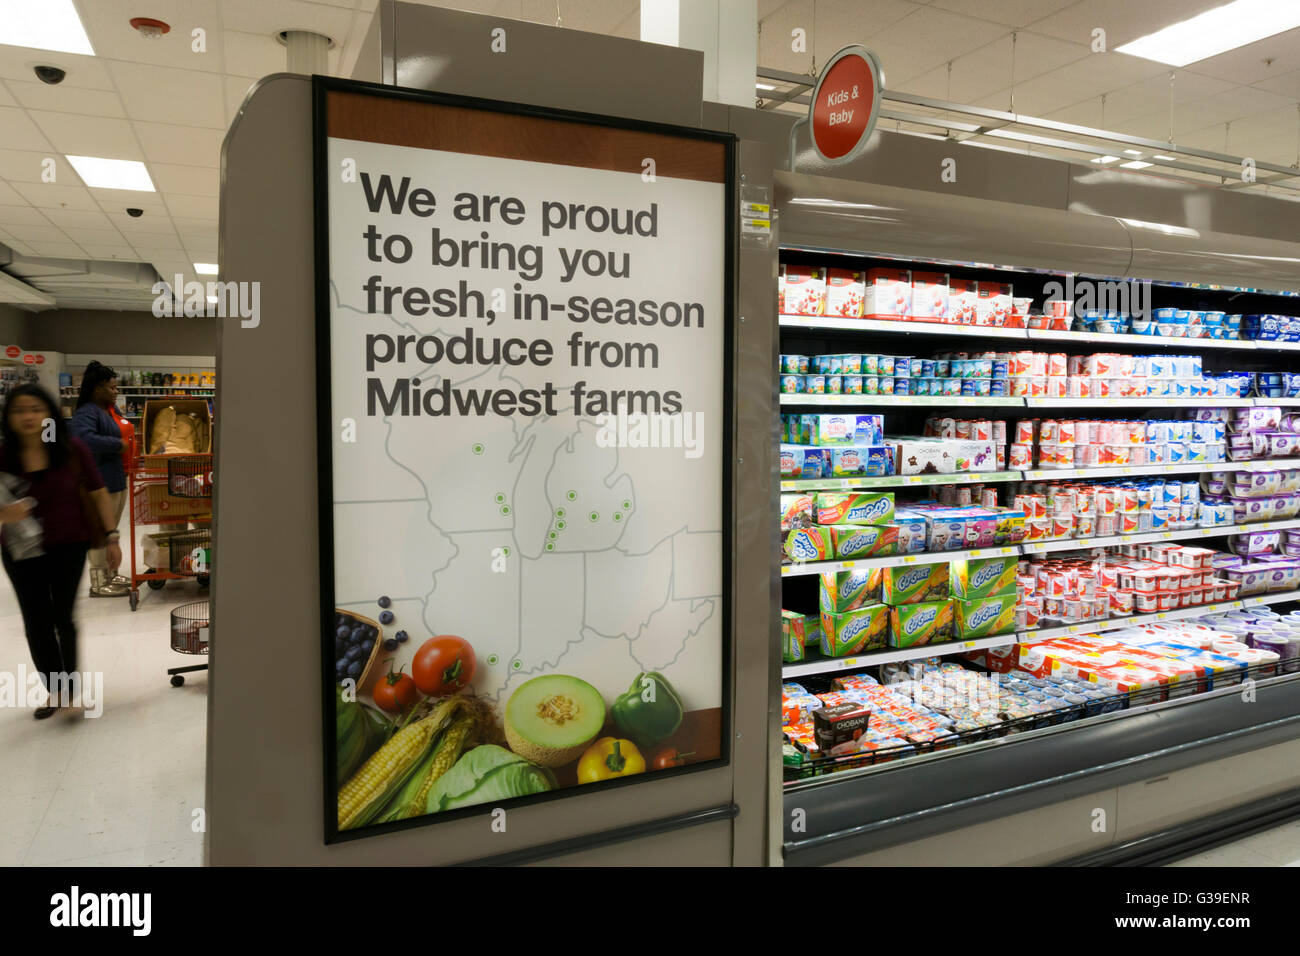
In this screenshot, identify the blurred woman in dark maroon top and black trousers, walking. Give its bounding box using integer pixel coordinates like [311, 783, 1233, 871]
[0, 385, 122, 721]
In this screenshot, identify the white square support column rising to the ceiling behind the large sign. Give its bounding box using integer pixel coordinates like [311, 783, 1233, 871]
[641, 0, 758, 107]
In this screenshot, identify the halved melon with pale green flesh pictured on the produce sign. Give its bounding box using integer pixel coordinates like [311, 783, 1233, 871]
[506, 674, 605, 767]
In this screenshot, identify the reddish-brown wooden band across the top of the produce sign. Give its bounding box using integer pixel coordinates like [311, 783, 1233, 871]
[326, 90, 727, 183]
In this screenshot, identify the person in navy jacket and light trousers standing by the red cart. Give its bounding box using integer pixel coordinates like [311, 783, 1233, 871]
[70, 362, 134, 597]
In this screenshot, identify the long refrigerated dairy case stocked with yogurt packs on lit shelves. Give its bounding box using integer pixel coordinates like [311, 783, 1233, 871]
[769, 173, 1300, 865]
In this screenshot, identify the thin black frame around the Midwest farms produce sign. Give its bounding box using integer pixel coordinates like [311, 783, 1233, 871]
[312, 75, 740, 844]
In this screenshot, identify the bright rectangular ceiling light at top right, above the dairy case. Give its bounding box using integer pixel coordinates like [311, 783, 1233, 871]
[1115, 0, 1300, 66]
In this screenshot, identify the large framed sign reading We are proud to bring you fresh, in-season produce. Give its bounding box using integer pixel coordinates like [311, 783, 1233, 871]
[316, 78, 736, 840]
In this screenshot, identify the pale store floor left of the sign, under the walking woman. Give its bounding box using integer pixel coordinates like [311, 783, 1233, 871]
[0, 575, 207, 866]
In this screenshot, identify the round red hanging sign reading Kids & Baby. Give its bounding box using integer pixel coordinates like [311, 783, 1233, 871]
[809, 44, 884, 163]
